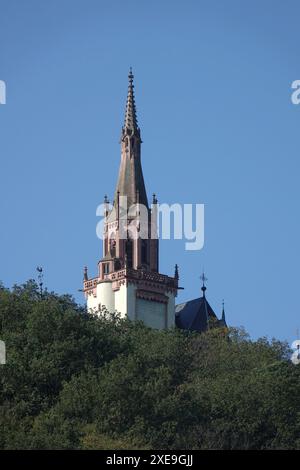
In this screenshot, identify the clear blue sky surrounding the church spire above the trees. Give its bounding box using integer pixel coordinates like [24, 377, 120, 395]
[0, 0, 300, 341]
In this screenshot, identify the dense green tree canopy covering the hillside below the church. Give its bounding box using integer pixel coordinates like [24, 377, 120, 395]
[0, 281, 300, 449]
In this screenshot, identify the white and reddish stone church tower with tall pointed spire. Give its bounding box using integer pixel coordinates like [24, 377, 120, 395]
[83, 69, 178, 329]
